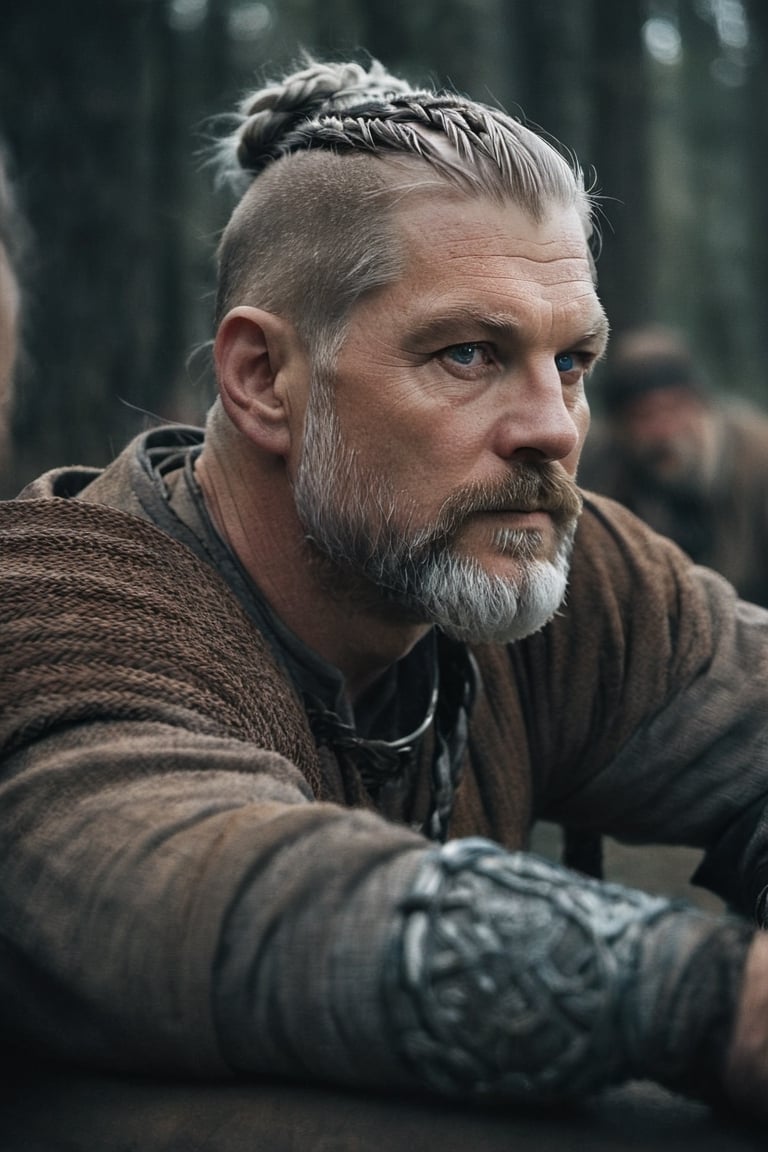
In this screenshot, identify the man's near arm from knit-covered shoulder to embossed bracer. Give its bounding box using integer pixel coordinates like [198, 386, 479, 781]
[0, 497, 759, 1099]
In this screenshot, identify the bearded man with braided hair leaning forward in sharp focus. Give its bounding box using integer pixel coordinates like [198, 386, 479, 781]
[0, 56, 768, 1107]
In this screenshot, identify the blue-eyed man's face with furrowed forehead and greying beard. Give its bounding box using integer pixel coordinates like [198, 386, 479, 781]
[295, 198, 606, 641]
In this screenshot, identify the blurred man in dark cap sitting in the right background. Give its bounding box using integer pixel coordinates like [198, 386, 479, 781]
[579, 325, 768, 605]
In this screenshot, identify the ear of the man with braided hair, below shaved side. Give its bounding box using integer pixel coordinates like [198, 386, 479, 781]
[214, 305, 310, 456]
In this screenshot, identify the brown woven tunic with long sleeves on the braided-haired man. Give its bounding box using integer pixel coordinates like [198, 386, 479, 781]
[0, 433, 768, 1083]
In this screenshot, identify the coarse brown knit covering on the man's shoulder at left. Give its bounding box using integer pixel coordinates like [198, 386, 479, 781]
[0, 498, 313, 765]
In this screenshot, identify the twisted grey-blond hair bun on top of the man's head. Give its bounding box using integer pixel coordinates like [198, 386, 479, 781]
[221, 58, 411, 182]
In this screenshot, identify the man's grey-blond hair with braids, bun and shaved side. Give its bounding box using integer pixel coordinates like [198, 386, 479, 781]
[210, 58, 592, 361]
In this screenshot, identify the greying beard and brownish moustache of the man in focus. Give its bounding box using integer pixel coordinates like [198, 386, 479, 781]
[294, 381, 580, 643]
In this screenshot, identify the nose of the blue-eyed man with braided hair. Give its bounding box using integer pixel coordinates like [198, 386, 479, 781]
[495, 364, 588, 461]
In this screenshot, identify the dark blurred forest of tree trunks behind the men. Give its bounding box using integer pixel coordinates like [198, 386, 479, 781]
[0, 0, 768, 490]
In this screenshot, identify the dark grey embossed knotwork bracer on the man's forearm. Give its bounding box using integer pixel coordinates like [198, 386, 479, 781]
[387, 839, 750, 1100]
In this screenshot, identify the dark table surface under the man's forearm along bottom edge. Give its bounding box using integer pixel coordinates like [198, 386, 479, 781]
[0, 1074, 768, 1152]
